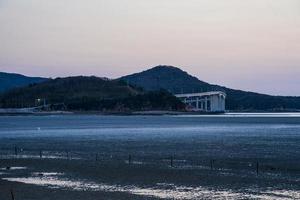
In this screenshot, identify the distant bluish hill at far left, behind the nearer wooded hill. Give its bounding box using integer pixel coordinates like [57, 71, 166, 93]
[0, 72, 48, 93]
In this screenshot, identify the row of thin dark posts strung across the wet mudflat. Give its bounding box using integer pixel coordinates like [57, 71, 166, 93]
[0, 146, 300, 176]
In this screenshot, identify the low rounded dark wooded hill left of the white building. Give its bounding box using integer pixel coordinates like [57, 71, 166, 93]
[0, 76, 184, 112]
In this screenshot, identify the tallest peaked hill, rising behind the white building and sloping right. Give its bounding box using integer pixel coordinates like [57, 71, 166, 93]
[120, 66, 300, 111]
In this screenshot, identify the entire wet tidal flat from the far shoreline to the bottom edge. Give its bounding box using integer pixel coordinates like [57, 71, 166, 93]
[0, 115, 300, 200]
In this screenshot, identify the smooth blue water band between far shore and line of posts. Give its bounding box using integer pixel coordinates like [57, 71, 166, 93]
[0, 114, 300, 160]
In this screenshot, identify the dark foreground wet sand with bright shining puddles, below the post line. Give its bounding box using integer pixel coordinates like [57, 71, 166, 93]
[0, 159, 300, 200]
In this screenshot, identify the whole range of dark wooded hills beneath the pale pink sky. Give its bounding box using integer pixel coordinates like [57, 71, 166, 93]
[0, 66, 300, 111]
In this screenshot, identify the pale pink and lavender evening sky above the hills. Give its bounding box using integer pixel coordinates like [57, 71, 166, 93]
[0, 0, 300, 96]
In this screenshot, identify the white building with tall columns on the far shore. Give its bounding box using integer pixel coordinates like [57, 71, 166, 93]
[175, 91, 226, 112]
